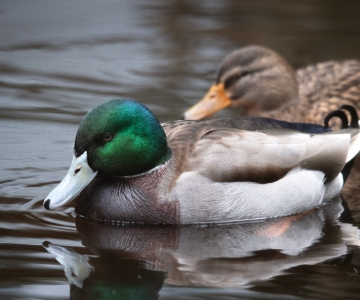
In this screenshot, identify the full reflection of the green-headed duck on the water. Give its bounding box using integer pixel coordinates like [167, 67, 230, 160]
[44, 198, 360, 299]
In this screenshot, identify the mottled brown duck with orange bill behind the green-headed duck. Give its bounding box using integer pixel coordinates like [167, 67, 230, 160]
[184, 46, 360, 124]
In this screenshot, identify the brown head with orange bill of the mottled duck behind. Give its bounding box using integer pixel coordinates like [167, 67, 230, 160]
[183, 46, 299, 120]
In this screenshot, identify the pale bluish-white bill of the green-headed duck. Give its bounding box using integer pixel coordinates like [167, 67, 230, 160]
[44, 152, 97, 209]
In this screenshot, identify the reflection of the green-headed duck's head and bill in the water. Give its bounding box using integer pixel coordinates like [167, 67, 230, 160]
[44, 243, 166, 300]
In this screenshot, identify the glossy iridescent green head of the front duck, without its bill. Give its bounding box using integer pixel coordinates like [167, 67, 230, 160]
[75, 99, 171, 176]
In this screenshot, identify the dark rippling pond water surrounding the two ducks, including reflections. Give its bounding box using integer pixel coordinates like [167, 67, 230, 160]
[0, 0, 360, 299]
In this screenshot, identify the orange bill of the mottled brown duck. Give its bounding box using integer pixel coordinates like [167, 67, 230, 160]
[184, 82, 231, 120]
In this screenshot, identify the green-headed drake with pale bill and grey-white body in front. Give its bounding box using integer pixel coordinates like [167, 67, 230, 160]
[43, 98, 360, 224]
